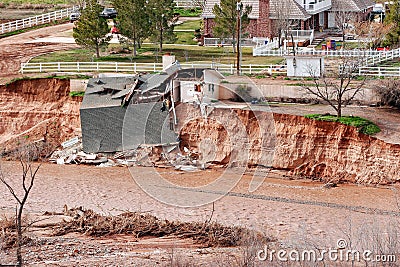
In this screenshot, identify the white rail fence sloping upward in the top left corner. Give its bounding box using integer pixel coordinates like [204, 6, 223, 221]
[0, 7, 78, 34]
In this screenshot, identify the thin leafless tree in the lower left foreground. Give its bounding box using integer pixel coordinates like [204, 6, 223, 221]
[0, 145, 42, 266]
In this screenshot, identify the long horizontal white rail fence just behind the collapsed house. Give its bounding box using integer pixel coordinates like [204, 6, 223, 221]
[20, 62, 286, 74]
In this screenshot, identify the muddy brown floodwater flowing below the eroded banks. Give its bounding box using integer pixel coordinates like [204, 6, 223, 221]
[0, 162, 399, 247]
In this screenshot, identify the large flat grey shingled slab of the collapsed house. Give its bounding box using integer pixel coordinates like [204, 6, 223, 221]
[81, 102, 177, 153]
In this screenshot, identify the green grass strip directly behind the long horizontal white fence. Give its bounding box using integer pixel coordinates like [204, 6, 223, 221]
[31, 44, 283, 65]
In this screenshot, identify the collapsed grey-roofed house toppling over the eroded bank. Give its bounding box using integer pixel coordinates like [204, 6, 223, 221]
[80, 62, 224, 153]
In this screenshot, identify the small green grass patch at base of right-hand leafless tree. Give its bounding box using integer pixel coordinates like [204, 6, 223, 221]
[304, 114, 381, 135]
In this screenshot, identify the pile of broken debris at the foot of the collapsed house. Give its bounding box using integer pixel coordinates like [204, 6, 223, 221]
[49, 137, 208, 171]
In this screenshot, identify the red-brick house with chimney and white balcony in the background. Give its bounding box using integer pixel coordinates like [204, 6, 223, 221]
[202, 0, 374, 38]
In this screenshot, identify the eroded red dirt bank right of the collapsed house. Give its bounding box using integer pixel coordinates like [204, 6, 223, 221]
[180, 106, 400, 184]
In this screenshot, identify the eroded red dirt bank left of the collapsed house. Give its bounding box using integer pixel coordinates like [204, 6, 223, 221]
[0, 78, 80, 153]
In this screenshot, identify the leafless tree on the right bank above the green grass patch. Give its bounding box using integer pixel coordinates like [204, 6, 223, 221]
[302, 57, 365, 118]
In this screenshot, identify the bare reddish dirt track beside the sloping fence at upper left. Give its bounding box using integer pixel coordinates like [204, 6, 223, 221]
[0, 23, 78, 84]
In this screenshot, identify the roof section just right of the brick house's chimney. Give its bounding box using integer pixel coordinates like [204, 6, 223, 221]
[269, 0, 311, 20]
